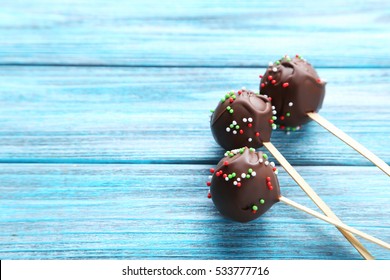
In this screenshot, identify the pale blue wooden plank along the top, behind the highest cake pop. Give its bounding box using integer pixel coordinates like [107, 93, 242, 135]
[0, 0, 390, 67]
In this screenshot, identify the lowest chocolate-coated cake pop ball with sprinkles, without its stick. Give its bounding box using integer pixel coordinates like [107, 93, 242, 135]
[210, 147, 280, 222]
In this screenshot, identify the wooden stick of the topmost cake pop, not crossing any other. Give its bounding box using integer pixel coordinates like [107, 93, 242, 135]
[307, 113, 390, 176]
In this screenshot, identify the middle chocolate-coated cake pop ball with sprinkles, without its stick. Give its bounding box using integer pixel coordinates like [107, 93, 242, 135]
[210, 90, 276, 150]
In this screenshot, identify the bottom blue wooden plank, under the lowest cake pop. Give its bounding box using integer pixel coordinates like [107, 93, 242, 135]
[0, 164, 390, 259]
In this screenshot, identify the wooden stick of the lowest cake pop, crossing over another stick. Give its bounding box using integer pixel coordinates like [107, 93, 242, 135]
[279, 196, 390, 250]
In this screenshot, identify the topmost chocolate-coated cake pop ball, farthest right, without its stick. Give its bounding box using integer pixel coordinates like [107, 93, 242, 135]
[260, 56, 326, 129]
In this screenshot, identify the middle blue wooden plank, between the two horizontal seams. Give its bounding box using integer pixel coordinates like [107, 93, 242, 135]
[0, 67, 390, 165]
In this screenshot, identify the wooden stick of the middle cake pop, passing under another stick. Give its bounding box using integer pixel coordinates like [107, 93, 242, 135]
[263, 142, 374, 260]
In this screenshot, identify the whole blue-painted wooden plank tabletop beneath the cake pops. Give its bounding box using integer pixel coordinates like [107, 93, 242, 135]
[0, 0, 390, 259]
